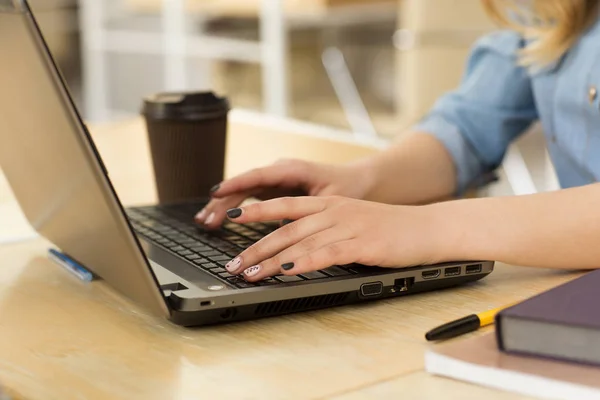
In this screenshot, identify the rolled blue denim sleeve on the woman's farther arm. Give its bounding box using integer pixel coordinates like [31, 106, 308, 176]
[413, 31, 538, 194]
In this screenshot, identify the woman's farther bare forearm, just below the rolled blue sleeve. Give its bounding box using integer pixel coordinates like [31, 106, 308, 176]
[359, 133, 456, 204]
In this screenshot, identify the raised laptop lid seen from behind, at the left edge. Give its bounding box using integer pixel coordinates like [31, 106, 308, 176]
[0, 0, 169, 316]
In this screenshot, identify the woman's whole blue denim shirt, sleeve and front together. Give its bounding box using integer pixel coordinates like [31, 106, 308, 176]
[414, 21, 600, 193]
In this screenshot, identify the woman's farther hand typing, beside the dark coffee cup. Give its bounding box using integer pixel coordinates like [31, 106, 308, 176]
[196, 160, 375, 229]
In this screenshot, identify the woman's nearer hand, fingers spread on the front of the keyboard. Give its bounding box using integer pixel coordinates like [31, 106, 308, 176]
[226, 197, 444, 282]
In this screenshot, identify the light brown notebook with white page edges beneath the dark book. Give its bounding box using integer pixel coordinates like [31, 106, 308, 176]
[425, 333, 600, 400]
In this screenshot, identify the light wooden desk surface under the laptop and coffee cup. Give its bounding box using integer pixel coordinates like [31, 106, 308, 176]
[0, 115, 576, 400]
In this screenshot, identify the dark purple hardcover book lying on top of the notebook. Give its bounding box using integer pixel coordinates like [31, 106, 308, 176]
[496, 270, 600, 365]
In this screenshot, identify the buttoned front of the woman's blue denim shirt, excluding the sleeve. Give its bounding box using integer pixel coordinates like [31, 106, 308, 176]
[531, 18, 600, 188]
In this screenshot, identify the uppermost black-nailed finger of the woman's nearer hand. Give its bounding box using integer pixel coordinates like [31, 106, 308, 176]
[227, 197, 328, 224]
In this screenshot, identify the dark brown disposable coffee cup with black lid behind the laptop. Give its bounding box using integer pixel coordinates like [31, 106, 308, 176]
[142, 92, 229, 204]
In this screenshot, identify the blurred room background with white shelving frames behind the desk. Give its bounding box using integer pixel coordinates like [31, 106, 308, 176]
[2, 0, 557, 209]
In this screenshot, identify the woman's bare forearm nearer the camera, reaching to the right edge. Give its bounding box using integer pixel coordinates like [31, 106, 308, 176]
[434, 184, 600, 269]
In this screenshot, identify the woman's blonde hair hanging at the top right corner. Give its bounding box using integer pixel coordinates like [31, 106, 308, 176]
[482, 0, 600, 66]
